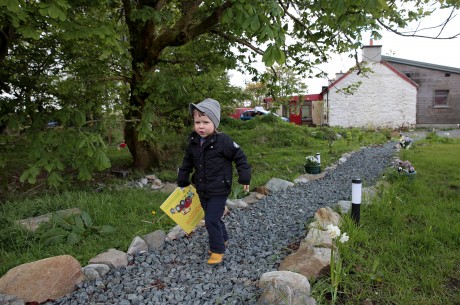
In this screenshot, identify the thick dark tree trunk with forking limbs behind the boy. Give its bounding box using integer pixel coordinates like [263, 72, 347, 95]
[122, 0, 229, 171]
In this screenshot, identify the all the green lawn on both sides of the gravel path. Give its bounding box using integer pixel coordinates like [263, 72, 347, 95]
[0, 121, 460, 304]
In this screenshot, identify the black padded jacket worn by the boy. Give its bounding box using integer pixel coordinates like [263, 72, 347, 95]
[177, 132, 251, 198]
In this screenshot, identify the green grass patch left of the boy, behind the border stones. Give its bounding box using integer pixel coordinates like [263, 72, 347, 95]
[0, 188, 173, 273]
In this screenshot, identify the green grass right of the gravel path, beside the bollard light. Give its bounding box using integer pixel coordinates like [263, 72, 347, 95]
[313, 139, 460, 305]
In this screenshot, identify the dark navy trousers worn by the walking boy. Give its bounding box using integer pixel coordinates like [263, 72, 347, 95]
[200, 197, 228, 253]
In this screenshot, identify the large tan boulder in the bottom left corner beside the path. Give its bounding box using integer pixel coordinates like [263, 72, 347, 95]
[0, 255, 85, 303]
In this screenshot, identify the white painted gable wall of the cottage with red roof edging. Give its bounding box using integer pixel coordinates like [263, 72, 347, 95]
[328, 62, 417, 128]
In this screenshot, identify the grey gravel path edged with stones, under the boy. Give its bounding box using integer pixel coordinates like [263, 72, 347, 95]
[46, 143, 395, 305]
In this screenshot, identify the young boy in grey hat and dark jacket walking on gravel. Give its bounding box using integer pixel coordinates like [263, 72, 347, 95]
[177, 98, 251, 264]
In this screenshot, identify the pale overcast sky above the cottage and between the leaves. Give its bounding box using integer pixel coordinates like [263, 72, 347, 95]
[229, 8, 460, 94]
